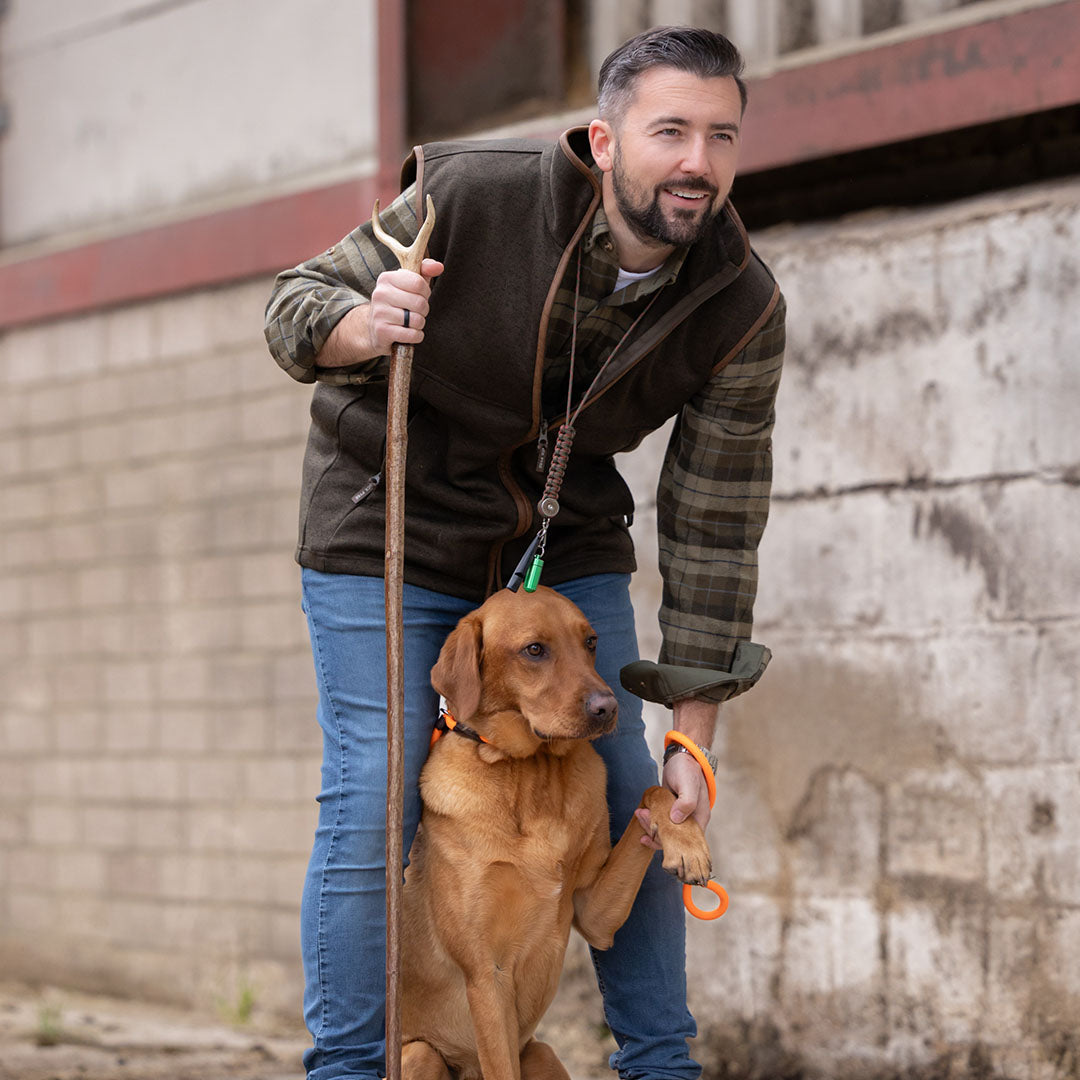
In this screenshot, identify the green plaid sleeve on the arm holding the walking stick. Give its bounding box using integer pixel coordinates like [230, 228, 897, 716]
[265, 187, 419, 386]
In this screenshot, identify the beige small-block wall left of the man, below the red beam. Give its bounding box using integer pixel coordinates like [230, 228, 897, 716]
[0, 281, 318, 1014]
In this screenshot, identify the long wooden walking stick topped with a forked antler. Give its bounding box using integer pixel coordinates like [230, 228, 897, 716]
[372, 195, 435, 1080]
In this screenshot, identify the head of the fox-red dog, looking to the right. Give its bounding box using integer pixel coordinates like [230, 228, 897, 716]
[431, 586, 618, 757]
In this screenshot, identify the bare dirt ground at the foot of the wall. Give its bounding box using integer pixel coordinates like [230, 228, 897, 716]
[0, 966, 615, 1080]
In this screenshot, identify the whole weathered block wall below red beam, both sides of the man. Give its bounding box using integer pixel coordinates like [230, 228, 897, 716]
[0, 172, 1080, 1078]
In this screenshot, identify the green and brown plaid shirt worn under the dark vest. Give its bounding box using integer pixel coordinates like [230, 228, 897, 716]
[266, 187, 784, 700]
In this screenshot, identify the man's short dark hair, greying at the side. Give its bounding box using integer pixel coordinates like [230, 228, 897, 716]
[596, 26, 746, 123]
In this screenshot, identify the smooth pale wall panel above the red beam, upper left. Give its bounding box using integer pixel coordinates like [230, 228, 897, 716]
[0, 0, 376, 245]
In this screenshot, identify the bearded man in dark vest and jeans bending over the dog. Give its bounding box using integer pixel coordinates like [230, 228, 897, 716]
[267, 28, 784, 1080]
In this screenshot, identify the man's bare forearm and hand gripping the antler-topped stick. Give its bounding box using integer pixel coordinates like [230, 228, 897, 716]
[315, 259, 445, 367]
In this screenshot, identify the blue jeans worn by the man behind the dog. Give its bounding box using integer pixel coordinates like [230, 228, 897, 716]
[301, 569, 701, 1080]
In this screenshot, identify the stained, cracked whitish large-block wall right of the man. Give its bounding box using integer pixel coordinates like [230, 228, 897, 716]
[622, 181, 1080, 1077]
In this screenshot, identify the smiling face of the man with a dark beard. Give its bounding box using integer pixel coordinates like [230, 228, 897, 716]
[611, 67, 742, 247]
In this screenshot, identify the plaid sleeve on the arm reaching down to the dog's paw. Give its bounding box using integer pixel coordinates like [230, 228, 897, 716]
[657, 297, 785, 701]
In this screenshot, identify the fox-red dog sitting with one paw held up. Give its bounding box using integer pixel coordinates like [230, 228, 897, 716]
[402, 586, 712, 1080]
